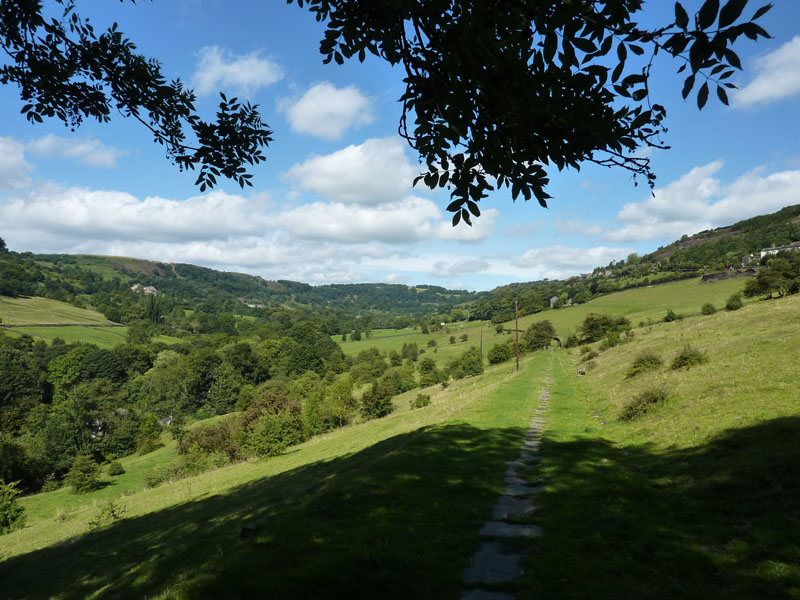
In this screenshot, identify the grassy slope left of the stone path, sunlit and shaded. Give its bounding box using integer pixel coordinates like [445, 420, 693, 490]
[0, 353, 548, 598]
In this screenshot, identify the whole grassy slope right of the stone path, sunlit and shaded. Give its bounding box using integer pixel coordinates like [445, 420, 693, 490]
[521, 297, 800, 600]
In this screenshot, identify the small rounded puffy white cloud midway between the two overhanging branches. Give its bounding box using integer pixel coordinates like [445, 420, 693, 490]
[280, 82, 375, 140]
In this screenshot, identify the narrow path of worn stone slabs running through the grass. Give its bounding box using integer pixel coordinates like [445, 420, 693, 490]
[460, 372, 552, 600]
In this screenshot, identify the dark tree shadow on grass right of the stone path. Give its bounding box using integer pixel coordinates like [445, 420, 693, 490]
[521, 417, 800, 600]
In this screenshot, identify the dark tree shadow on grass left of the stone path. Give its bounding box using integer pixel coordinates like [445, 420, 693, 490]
[0, 424, 523, 599]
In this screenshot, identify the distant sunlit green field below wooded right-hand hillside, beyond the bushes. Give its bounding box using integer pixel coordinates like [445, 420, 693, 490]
[506, 278, 745, 337]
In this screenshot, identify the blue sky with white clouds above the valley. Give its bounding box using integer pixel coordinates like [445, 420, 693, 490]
[0, 0, 800, 290]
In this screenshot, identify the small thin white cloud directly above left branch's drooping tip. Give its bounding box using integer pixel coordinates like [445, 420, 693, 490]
[192, 46, 283, 95]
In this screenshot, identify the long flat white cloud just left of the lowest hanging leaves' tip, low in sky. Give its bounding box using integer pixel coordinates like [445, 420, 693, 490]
[277, 196, 441, 244]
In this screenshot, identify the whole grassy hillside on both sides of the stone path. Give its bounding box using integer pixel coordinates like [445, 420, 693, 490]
[0, 282, 800, 600]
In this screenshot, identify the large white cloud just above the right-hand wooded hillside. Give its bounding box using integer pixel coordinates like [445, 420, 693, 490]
[606, 161, 800, 242]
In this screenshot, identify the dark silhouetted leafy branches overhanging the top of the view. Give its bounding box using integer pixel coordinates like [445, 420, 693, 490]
[0, 0, 771, 225]
